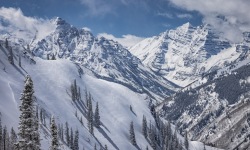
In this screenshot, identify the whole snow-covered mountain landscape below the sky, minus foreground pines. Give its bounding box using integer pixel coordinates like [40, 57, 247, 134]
[0, 17, 250, 150]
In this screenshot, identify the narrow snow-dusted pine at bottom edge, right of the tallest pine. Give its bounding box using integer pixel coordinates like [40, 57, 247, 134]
[50, 116, 59, 150]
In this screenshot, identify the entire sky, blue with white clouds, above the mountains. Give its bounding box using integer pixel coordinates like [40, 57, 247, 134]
[0, 0, 250, 47]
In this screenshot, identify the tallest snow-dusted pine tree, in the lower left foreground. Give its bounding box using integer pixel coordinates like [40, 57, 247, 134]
[16, 75, 39, 150]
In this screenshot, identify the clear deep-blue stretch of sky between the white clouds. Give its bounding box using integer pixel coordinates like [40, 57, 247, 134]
[1, 0, 202, 37]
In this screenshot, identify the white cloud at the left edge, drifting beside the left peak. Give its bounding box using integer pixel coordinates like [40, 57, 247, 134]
[0, 7, 55, 42]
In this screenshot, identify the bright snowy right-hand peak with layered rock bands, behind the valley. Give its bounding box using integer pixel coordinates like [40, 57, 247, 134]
[130, 23, 247, 87]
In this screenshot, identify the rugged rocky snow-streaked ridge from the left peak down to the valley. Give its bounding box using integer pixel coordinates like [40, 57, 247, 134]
[31, 18, 178, 100]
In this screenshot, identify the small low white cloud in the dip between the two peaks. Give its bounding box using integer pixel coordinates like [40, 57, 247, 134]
[97, 33, 145, 48]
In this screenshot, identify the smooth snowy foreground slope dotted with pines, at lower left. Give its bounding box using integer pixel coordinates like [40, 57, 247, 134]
[0, 37, 223, 150]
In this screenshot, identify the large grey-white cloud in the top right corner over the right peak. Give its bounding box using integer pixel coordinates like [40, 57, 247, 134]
[170, 0, 250, 42]
